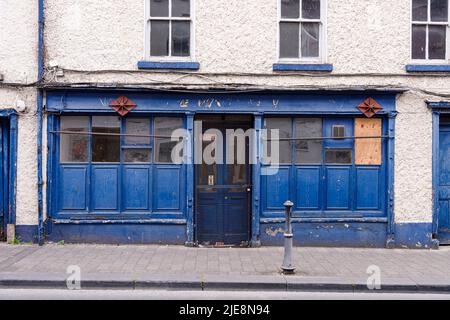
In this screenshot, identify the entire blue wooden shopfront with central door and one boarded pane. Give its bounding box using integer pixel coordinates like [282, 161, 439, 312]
[45, 89, 397, 247]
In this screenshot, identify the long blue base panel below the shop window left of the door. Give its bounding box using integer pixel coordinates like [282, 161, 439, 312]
[46, 224, 187, 245]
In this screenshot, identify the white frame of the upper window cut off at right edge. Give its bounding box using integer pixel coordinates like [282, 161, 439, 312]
[409, 0, 450, 65]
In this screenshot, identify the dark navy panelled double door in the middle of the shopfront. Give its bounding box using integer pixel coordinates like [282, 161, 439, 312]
[196, 119, 251, 245]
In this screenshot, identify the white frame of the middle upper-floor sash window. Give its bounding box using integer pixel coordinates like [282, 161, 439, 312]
[277, 0, 328, 63]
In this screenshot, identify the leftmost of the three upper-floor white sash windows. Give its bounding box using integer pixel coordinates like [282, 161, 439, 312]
[146, 0, 193, 59]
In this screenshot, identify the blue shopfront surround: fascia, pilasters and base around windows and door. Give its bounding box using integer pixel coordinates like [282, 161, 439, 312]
[46, 90, 397, 247]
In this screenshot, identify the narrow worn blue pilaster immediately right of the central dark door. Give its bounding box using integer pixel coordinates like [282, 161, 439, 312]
[251, 114, 263, 247]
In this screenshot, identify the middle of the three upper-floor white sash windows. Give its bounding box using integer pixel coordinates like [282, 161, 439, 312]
[279, 0, 326, 61]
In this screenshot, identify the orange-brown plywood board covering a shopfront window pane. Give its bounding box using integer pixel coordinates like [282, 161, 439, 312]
[355, 118, 382, 165]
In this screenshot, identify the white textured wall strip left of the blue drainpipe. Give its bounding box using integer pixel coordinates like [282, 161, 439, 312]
[0, 0, 38, 225]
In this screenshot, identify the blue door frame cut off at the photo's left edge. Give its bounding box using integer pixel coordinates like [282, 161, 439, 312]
[0, 109, 17, 240]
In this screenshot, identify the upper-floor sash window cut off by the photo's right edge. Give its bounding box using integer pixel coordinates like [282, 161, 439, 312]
[411, 0, 450, 62]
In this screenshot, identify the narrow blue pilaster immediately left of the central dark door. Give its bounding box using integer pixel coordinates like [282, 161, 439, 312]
[185, 114, 195, 246]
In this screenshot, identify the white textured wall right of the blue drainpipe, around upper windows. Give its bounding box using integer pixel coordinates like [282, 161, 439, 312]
[22, 0, 450, 222]
